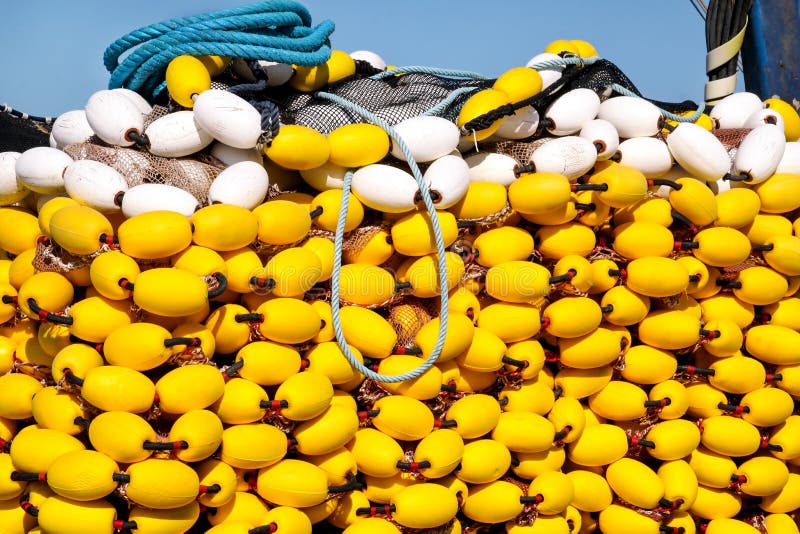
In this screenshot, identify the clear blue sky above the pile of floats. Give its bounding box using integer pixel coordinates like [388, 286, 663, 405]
[0, 0, 724, 116]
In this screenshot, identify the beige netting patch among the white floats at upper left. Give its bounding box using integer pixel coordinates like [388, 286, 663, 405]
[64, 142, 225, 206]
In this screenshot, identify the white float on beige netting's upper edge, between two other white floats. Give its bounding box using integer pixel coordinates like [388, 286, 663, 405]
[144, 110, 214, 158]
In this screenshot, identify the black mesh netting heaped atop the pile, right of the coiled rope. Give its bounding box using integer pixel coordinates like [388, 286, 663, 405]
[268, 59, 697, 134]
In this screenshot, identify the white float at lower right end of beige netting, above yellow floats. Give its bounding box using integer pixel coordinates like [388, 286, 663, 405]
[208, 161, 269, 210]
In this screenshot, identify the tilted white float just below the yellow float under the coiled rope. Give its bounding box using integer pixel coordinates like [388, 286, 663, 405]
[194, 89, 261, 148]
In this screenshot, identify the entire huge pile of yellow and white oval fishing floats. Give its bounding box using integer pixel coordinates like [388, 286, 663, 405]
[0, 37, 800, 534]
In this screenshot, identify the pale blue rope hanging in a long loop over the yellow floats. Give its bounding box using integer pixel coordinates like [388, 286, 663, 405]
[315, 92, 449, 382]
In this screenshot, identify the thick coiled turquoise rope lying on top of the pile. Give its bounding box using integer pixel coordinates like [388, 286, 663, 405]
[103, 0, 334, 96]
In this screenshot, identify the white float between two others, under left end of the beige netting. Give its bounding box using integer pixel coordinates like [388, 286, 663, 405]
[64, 159, 128, 211]
